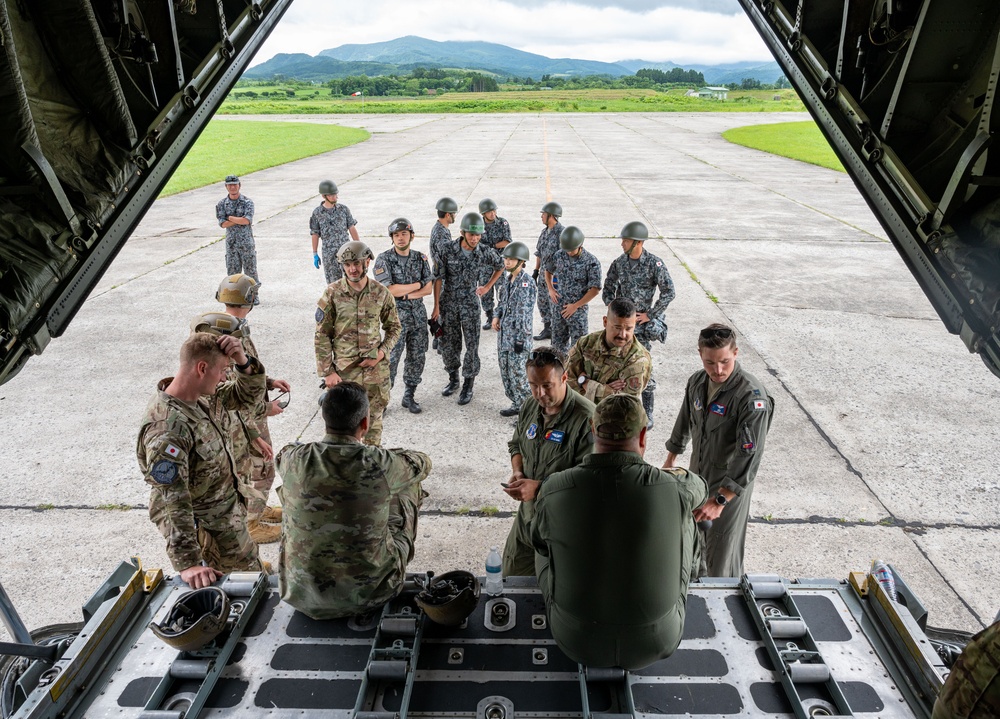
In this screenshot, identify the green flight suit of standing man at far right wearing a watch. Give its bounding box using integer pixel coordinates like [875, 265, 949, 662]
[667, 362, 774, 577]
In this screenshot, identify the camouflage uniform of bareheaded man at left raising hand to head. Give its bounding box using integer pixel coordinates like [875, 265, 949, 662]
[136, 357, 265, 573]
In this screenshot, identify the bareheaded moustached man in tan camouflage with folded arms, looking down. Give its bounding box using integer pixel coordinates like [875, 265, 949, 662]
[566, 297, 653, 404]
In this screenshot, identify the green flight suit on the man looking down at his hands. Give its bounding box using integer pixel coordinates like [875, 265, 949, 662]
[503, 387, 594, 577]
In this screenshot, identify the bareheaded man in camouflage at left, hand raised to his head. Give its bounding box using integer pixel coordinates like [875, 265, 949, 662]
[136, 332, 265, 589]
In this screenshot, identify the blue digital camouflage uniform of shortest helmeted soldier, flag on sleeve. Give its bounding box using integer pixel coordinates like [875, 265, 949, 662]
[494, 268, 535, 407]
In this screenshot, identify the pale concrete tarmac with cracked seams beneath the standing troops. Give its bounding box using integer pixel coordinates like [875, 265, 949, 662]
[0, 113, 1000, 640]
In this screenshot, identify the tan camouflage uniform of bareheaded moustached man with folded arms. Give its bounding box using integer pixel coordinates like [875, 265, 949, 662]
[566, 330, 653, 404]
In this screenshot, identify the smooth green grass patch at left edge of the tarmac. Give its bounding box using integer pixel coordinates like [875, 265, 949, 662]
[161, 120, 371, 197]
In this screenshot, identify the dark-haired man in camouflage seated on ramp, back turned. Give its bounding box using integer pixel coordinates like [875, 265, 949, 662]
[278, 382, 431, 619]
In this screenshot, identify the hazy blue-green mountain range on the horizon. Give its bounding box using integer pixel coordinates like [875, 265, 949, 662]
[243, 35, 782, 85]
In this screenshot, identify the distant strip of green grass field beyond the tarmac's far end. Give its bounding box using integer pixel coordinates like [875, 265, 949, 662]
[219, 85, 805, 115]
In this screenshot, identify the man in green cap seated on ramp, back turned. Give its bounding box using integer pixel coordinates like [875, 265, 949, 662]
[531, 394, 708, 670]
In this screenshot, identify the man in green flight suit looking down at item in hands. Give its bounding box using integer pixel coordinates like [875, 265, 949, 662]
[503, 347, 594, 577]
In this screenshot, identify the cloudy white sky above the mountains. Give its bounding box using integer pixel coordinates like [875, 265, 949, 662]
[254, 0, 772, 65]
